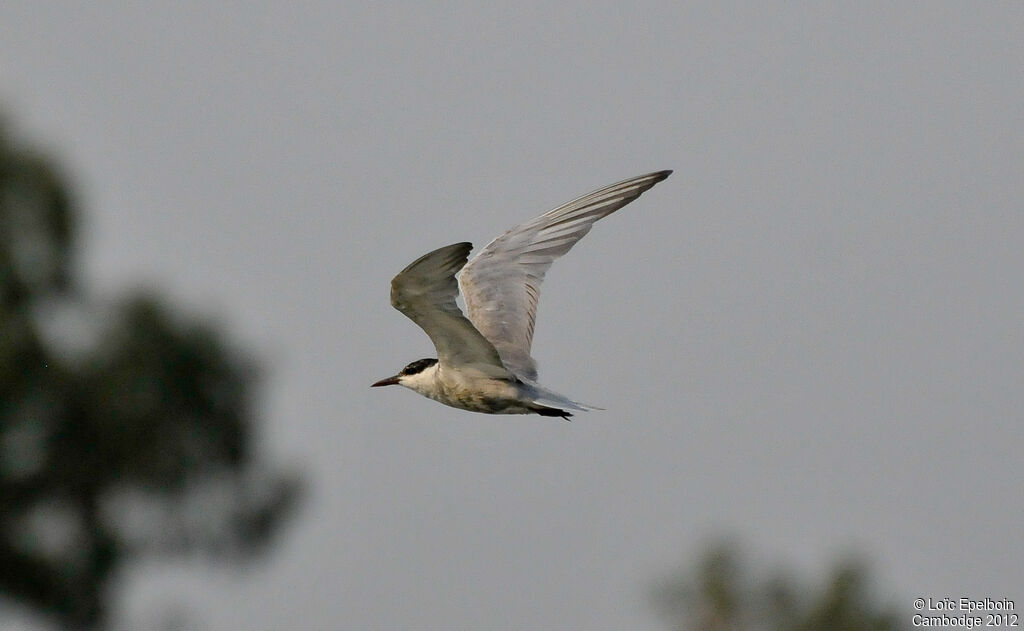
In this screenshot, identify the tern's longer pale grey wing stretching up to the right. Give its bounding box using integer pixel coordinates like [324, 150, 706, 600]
[459, 171, 672, 380]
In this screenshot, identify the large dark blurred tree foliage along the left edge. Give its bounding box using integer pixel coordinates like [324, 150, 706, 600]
[0, 117, 299, 630]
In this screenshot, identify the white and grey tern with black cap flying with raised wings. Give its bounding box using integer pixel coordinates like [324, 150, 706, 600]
[371, 170, 672, 420]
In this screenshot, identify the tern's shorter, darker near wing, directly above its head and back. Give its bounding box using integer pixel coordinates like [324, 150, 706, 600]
[391, 243, 508, 377]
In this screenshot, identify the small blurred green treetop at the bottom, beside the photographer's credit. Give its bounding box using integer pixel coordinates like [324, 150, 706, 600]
[654, 543, 905, 631]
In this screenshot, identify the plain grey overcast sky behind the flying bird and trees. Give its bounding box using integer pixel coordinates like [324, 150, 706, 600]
[0, 2, 1024, 631]
